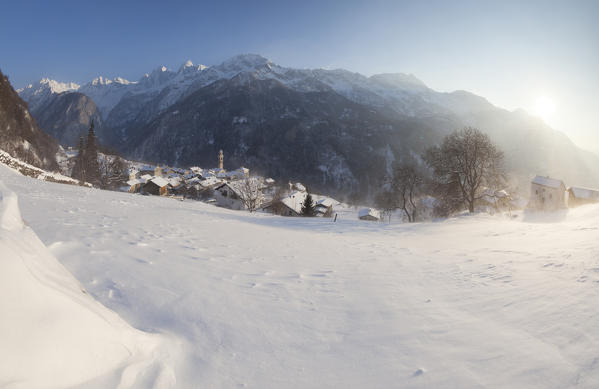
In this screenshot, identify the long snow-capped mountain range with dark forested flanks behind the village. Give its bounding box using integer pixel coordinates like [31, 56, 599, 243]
[19, 54, 599, 195]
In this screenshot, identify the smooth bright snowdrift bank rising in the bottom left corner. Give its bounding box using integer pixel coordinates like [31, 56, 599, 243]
[0, 177, 174, 388]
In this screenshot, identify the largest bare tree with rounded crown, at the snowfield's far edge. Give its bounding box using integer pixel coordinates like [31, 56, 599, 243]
[424, 127, 504, 212]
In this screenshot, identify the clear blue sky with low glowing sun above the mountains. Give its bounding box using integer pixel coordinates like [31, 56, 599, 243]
[0, 0, 599, 152]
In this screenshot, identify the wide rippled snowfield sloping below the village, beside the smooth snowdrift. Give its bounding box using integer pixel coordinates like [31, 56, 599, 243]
[0, 162, 599, 388]
